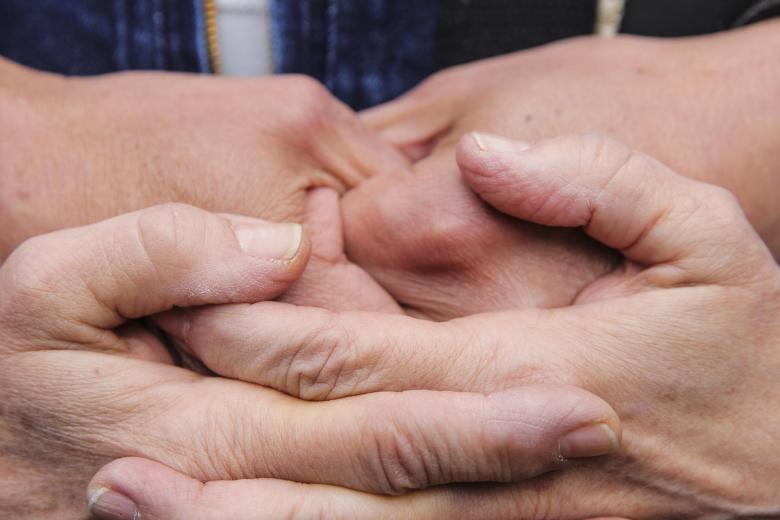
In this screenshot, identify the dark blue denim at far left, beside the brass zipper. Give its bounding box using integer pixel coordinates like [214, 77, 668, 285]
[0, 0, 208, 75]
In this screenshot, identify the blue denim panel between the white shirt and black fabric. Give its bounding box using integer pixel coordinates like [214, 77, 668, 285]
[271, 0, 439, 109]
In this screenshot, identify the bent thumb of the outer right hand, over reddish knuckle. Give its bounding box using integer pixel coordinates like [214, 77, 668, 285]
[457, 130, 767, 285]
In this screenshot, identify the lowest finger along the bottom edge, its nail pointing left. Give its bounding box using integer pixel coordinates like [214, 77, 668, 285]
[87, 458, 672, 520]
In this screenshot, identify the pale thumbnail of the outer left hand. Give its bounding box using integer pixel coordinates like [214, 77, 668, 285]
[233, 222, 303, 260]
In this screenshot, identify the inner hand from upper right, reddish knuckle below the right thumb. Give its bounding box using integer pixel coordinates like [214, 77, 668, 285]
[344, 20, 780, 319]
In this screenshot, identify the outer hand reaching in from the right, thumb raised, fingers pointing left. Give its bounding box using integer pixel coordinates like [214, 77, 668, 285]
[120, 136, 780, 519]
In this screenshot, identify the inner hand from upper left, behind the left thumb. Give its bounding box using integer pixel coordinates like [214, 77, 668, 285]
[0, 60, 406, 310]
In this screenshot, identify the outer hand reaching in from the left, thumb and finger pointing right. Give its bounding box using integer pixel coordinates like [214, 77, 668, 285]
[0, 198, 620, 519]
